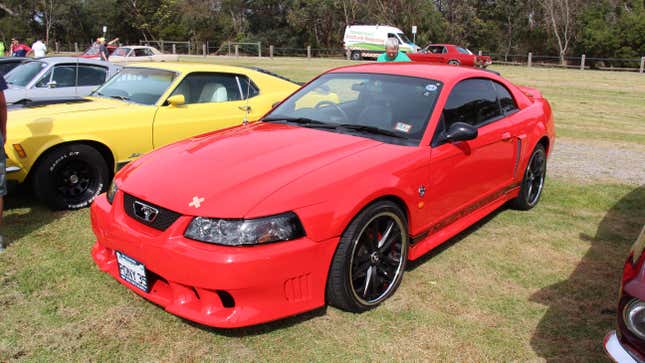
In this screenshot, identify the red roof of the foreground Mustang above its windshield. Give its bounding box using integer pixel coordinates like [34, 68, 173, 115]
[329, 62, 495, 83]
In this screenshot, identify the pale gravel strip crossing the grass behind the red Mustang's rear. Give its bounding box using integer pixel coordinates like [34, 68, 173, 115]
[547, 139, 645, 185]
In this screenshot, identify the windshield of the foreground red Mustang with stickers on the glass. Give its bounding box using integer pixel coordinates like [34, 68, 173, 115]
[264, 73, 442, 145]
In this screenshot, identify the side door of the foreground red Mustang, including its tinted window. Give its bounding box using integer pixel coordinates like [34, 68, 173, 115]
[428, 78, 517, 226]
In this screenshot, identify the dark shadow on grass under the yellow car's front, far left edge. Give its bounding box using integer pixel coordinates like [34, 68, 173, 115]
[0, 186, 65, 248]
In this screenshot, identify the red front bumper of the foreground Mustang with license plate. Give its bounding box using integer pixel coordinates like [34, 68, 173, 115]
[91, 192, 338, 328]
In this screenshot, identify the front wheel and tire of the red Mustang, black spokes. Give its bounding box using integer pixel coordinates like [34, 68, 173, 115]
[327, 201, 408, 313]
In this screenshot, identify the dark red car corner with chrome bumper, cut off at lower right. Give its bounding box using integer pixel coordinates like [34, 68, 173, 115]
[604, 226, 645, 362]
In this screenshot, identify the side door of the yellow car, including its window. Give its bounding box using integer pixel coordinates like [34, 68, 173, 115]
[153, 72, 261, 148]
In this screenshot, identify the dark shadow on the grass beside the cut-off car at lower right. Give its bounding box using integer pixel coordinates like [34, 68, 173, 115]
[530, 185, 645, 361]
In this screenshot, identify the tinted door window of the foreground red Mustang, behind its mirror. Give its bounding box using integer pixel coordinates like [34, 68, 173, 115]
[443, 78, 501, 129]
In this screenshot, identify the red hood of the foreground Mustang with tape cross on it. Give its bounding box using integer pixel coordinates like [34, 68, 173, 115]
[117, 122, 382, 218]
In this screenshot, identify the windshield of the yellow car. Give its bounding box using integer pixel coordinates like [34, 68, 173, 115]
[93, 68, 175, 105]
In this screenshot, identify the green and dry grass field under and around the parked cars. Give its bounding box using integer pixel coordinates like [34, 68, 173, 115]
[0, 58, 645, 362]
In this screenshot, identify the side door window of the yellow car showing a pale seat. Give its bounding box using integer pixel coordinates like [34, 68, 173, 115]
[171, 73, 242, 104]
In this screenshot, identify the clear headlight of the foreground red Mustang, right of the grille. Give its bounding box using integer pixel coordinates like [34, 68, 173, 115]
[184, 212, 305, 246]
